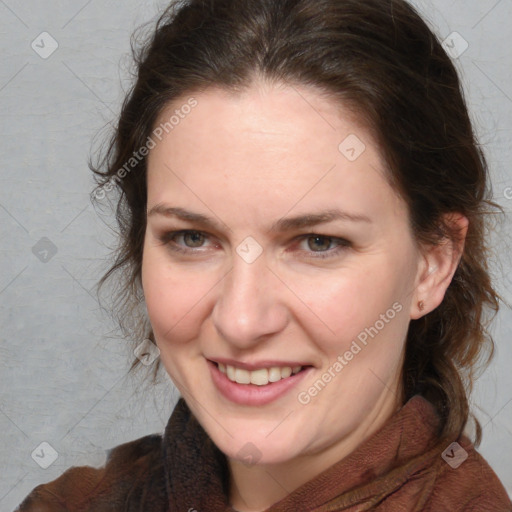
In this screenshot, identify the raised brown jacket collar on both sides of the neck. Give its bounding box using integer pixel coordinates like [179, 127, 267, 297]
[163, 395, 440, 512]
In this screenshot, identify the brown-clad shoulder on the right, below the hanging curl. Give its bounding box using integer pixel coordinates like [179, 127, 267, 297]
[427, 437, 512, 512]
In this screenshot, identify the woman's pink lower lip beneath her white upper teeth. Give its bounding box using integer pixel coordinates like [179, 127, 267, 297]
[208, 361, 312, 405]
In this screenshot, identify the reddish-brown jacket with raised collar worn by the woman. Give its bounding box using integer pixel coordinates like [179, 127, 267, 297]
[18, 395, 512, 512]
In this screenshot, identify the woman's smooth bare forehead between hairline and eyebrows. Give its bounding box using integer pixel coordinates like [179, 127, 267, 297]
[148, 83, 403, 230]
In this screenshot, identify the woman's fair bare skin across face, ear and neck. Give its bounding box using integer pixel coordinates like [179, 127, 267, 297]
[142, 81, 467, 512]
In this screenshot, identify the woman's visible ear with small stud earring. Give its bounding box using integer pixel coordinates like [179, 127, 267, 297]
[410, 213, 469, 320]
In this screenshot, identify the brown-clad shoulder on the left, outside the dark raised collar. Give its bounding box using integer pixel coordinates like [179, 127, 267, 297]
[16, 434, 164, 512]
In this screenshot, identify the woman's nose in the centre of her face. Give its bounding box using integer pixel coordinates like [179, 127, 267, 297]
[212, 254, 289, 350]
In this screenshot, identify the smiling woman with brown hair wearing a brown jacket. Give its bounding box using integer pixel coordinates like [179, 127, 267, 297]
[19, 0, 512, 512]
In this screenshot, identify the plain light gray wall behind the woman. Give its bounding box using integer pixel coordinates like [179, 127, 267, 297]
[0, 0, 512, 511]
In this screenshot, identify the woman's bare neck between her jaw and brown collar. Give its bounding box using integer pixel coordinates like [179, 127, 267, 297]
[228, 393, 400, 512]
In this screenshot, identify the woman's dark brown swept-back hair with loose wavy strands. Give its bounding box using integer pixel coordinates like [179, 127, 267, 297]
[91, 0, 499, 444]
